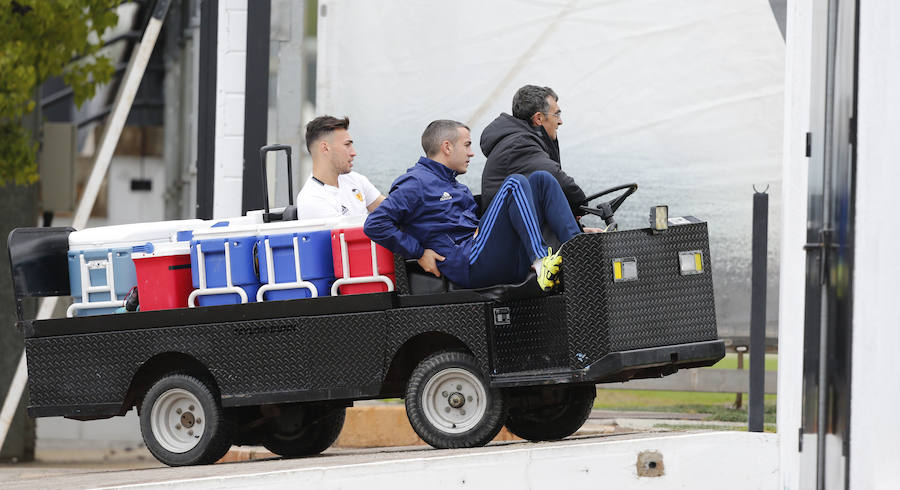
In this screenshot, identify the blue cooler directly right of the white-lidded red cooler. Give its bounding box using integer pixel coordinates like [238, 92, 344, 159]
[188, 222, 260, 306]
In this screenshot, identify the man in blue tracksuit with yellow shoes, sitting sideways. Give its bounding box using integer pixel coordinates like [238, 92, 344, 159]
[365, 120, 580, 290]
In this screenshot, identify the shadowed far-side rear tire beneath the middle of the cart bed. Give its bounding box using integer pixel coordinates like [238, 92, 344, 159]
[263, 405, 346, 458]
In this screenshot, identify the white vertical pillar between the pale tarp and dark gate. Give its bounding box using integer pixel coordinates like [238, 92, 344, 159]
[777, 0, 814, 488]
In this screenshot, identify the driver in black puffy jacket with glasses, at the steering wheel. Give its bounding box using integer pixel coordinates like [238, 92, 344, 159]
[481, 85, 585, 216]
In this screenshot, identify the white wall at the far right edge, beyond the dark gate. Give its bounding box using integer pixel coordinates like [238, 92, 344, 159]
[852, 0, 900, 488]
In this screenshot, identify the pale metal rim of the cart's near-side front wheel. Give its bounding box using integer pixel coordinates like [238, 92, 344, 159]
[422, 368, 487, 434]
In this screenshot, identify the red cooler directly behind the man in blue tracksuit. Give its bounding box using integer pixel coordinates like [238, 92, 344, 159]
[331, 226, 394, 296]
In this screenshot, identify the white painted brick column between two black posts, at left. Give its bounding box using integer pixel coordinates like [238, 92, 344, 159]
[213, 0, 248, 218]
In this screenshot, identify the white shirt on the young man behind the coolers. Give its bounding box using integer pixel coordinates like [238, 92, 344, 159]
[297, 172, 381, 219]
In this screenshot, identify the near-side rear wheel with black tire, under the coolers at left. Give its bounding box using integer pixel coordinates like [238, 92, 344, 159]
[141, 374, 234, 466]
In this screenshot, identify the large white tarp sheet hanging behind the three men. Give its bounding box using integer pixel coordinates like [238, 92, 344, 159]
[316, 0, 784, 336]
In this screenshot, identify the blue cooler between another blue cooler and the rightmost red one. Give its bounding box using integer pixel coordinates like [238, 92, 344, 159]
[256, 228, 334, 301]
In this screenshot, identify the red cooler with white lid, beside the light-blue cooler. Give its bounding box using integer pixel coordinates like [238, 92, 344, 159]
[131, 242, 194, 311]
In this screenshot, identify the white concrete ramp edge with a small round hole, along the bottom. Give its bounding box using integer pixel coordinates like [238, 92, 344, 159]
[84, 432, 779, 490]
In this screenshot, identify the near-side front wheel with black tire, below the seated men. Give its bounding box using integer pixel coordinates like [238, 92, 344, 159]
[406, 351, 505, 449]
